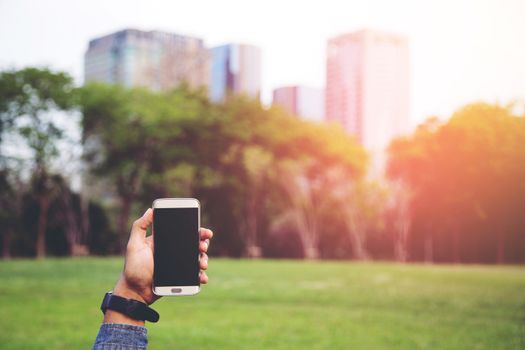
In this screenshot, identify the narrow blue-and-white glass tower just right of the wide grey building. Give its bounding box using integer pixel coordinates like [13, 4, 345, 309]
[209, 44, 261, 102]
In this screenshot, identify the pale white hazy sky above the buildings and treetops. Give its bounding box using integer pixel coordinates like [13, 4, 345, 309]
[0, 0, 525, 125]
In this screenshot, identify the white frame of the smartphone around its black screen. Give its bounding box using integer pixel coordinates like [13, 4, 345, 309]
[152, 198, 201, 296]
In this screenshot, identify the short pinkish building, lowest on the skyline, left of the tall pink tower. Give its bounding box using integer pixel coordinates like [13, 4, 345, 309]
[273, 86, 324, 122]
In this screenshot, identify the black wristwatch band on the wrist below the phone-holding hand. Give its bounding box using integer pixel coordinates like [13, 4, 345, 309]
[100, 292, 159, 322]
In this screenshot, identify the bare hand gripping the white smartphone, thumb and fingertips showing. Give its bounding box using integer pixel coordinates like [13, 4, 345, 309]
[109, 208, 213, 314]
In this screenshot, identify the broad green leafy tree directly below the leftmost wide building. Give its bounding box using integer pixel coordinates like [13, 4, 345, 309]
[80, 83, 212, 244]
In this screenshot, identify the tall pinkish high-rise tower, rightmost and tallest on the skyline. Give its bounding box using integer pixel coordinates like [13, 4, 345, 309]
[326, 30, 410, 154]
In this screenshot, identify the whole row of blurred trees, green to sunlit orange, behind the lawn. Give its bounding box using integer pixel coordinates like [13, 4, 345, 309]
[0, 68, 525, 262]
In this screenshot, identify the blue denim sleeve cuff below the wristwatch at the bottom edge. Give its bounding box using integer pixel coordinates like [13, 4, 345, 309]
[92, 323, 148, 350]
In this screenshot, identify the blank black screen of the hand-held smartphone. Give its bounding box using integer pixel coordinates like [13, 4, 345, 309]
[153, 208, 200, 287]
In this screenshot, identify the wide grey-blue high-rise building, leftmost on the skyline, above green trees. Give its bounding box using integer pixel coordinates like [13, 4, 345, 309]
[84, 29, 209, 90]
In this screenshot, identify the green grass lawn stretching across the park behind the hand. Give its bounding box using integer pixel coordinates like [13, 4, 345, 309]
[0, 258, 525, 349]
